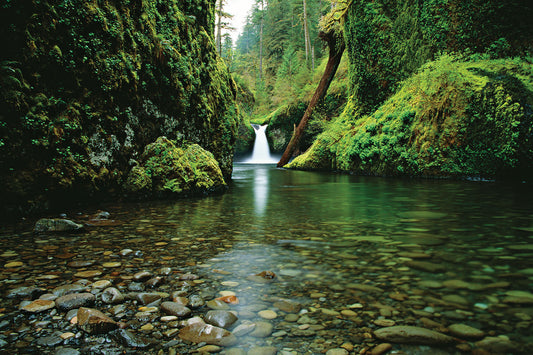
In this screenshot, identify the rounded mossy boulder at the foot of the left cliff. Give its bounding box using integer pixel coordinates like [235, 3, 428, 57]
[124, 137, 226, 196]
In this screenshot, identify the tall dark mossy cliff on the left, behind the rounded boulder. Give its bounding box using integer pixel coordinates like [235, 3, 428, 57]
[0, 0, 238, 212]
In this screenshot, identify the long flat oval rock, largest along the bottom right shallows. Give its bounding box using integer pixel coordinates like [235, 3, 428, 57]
[374, 325, 454, 345]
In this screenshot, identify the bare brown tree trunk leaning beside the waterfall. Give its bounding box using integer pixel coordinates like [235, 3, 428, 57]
[278, 31, 345, 168]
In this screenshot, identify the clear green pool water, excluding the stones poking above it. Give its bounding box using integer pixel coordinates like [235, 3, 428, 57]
[0, 164, 533, 354]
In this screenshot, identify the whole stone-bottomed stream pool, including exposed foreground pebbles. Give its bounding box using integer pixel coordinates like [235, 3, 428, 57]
[0, 164, 533, 355]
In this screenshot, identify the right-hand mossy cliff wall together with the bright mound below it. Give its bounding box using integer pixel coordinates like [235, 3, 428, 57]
[289, 0, 533, 178]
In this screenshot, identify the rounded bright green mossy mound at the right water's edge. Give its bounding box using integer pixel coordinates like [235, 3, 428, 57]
[289, 56, 533, 178]
